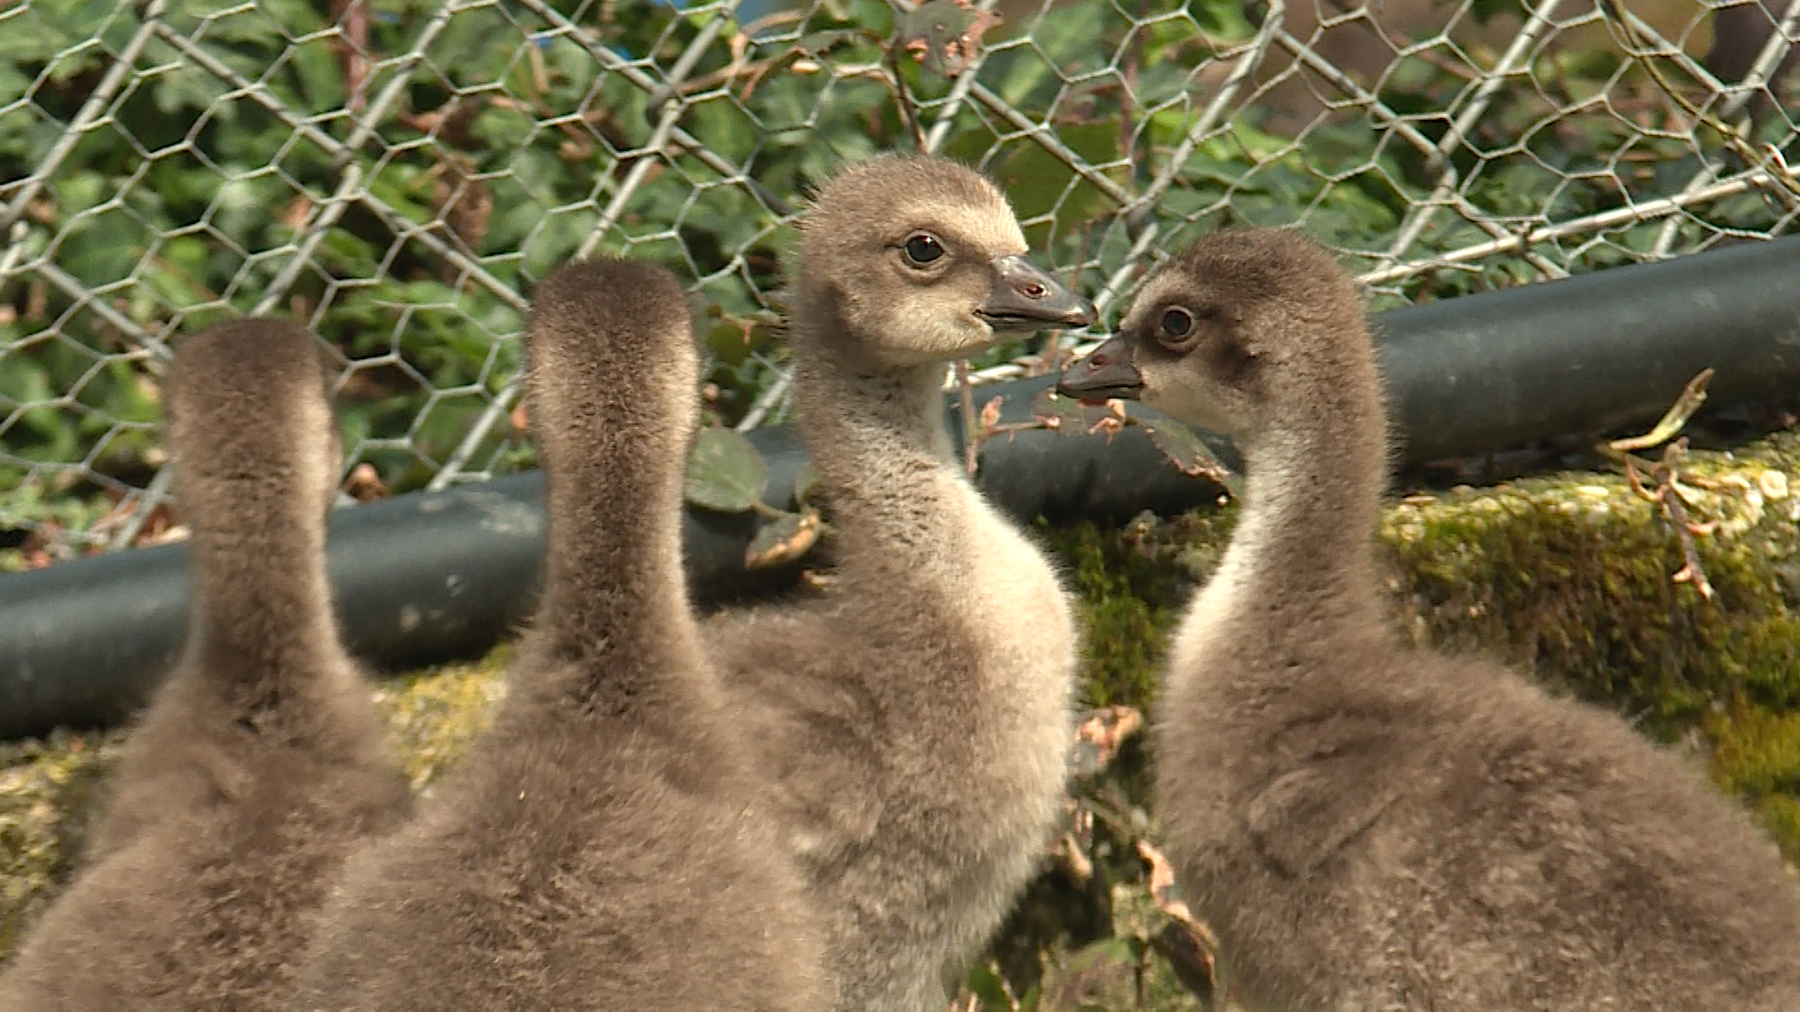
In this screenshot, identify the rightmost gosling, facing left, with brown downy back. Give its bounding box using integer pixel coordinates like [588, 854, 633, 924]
[1062, 230, 1800, 1012]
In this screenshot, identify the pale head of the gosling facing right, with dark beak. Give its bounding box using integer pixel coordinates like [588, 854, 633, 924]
[799, 155, 1094, 366]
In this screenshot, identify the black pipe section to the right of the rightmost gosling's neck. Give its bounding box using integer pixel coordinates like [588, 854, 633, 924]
[1377, 236, 1800, 461]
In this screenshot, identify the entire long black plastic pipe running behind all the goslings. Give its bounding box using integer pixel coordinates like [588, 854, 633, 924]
[0, 236, 1800, 738]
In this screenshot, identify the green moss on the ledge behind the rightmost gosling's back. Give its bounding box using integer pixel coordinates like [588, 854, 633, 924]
[1382, 475, 1800, 727]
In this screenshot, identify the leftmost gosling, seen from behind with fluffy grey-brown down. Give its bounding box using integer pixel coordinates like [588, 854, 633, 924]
[0, 321, 409, 1012]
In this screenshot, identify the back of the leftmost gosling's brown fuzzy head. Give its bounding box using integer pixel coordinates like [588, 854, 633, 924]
[164, 319, 344, 520]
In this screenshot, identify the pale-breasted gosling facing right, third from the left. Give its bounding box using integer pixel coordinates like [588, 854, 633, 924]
[707, 155, 1093, 1012]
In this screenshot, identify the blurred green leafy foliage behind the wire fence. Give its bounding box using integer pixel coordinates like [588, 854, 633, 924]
[0, 0, 1777, 518]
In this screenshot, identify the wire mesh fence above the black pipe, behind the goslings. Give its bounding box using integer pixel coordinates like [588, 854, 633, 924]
[0, 0, 1800, 565]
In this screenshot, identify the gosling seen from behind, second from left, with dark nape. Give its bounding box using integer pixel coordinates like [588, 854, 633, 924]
[297, 259, 828, 1012]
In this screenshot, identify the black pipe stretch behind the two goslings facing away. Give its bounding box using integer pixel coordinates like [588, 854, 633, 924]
[0, 421, 806, 740]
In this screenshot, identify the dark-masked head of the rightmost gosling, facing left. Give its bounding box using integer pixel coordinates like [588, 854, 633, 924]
[1057, 229, 1375, 438]
